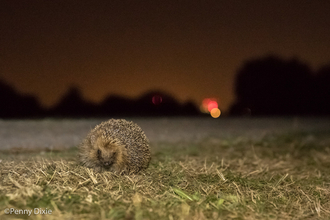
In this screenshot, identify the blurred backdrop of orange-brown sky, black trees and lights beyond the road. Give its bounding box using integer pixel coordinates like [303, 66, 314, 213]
[0, 0, 330, 118]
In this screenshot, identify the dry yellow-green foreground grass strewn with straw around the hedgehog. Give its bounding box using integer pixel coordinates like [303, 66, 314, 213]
[0, 133, 330, 219]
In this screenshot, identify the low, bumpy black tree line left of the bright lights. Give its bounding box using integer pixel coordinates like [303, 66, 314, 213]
[0, 80, 201, 118]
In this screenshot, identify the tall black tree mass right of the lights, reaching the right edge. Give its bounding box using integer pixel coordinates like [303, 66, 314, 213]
[230, 55, 330, 116]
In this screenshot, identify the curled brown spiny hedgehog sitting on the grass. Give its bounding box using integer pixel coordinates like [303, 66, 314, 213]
[79, 119, 151, 174]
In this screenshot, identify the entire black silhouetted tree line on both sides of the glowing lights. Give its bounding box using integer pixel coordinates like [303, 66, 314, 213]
[0, 55, 330, 118]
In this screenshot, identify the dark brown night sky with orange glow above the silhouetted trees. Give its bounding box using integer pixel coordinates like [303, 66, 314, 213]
[0, 0, 330, 110]
